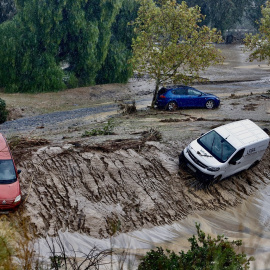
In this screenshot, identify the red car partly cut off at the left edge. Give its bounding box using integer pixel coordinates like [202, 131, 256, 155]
[0, 133, 22, 209]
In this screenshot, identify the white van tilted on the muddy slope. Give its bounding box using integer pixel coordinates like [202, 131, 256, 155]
[179, 119, 270, 182]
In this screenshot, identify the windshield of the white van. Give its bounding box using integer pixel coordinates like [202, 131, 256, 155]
[198, 130, 236, 163]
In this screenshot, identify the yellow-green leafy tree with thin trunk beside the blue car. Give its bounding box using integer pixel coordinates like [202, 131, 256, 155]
[132, 0, 222, 107]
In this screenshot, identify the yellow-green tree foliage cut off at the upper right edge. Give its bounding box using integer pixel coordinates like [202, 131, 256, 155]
[244, 1, 270, 64]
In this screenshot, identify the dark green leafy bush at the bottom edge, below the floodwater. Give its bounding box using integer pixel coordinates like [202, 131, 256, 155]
[138, 224, 254, 270]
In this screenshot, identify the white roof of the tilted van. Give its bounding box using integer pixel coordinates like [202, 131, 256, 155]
[214, 119, 269, 149]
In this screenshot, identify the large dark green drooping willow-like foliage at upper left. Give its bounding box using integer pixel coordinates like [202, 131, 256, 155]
[0, 0, 127, 92]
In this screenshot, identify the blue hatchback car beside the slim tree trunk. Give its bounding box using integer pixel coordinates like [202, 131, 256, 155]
[156, 85, 220, 111]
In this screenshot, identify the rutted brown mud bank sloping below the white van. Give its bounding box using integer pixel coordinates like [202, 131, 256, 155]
[18, 142, 270, 237]
